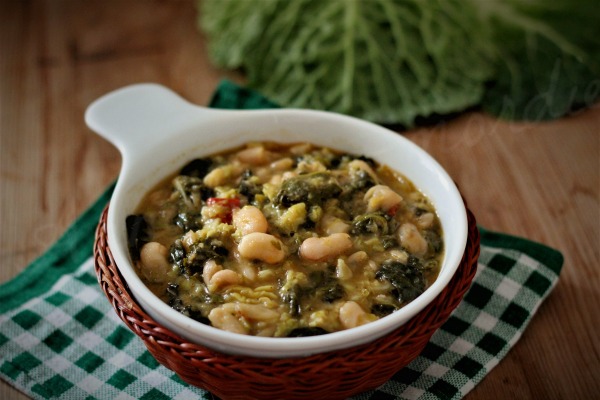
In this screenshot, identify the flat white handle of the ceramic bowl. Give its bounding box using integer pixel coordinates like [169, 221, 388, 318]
[85, 83, 217, 158]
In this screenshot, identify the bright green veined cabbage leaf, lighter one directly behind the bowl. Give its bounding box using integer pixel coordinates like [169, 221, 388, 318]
[201, 0, 492, 125]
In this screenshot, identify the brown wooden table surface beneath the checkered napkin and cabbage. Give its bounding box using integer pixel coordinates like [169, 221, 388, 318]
[0, 0, 600, 400]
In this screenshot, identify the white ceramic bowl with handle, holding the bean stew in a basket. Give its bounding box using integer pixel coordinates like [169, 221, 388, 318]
[85, 84, 467, 358]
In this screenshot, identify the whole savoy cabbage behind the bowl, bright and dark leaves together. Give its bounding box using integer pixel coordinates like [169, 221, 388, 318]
[199, 0, 600, 126]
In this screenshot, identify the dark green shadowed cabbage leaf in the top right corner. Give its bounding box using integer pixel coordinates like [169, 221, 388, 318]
[472, 0, 600, 121]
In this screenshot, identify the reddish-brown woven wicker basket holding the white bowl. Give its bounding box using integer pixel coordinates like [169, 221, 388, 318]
[94, 203, 479, 400]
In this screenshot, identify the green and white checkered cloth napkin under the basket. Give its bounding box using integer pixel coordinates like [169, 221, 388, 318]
[0, 81, 563, 400]
